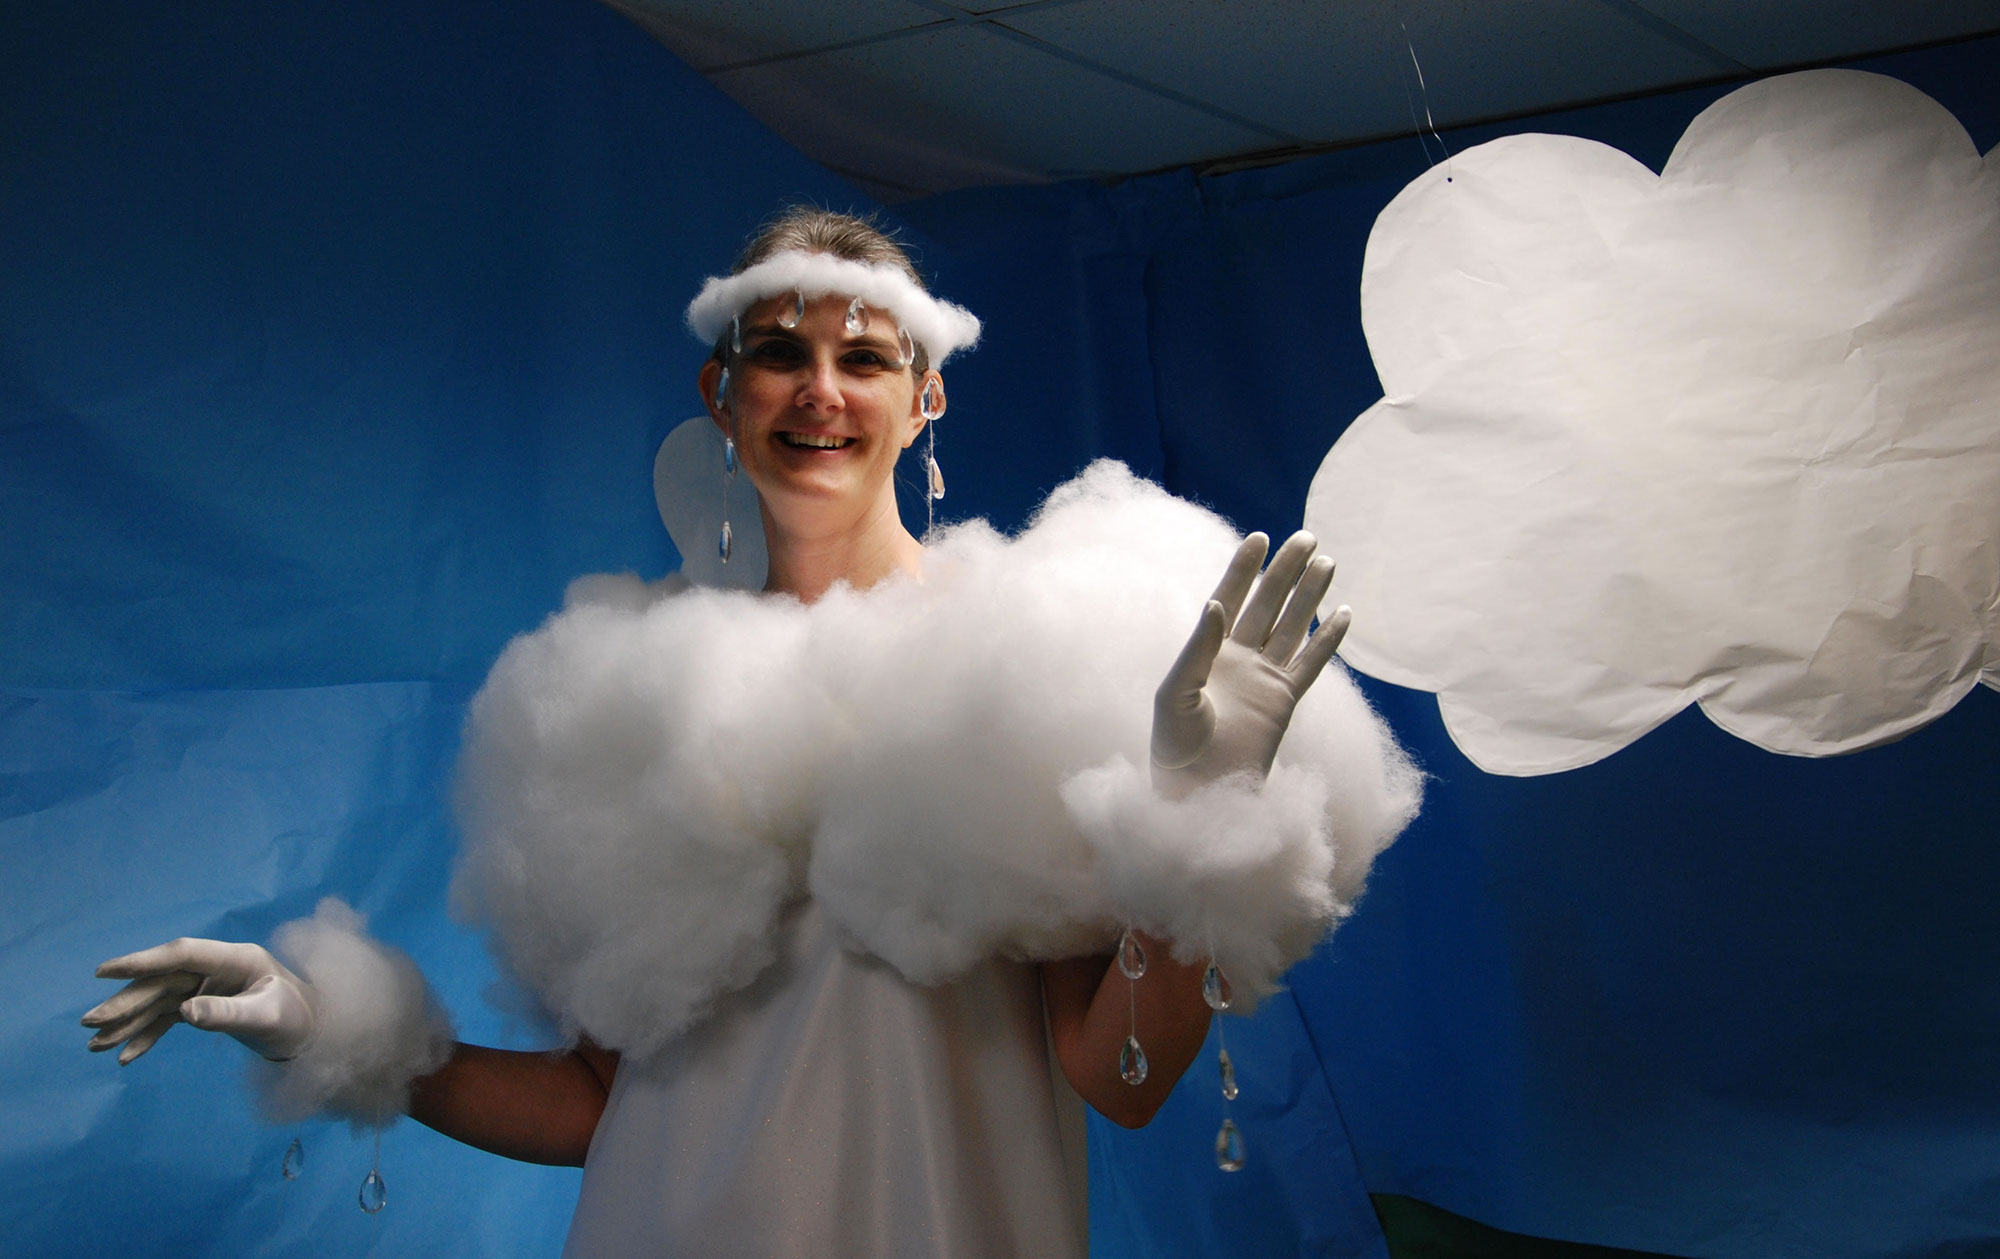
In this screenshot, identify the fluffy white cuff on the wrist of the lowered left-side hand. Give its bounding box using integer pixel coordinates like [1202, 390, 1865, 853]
[258, 897, 454, 1127]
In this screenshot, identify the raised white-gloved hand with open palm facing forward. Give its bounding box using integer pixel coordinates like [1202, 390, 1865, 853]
[1152, 532, 1352, 799]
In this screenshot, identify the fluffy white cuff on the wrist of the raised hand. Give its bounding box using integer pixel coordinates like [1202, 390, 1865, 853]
[1062, 757, 1348, 1011]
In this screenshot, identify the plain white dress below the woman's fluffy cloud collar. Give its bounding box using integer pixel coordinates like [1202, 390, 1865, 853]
[564, 899, 1088, 1259]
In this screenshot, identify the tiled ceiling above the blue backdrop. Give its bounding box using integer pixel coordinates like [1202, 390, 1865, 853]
[606, 0, 2000, 200]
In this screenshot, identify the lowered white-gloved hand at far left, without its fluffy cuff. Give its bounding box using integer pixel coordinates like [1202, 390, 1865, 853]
[84, 939, 318, 1063]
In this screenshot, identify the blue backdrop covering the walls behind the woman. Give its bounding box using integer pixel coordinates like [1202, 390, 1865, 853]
[0, 0, 2000, 1257]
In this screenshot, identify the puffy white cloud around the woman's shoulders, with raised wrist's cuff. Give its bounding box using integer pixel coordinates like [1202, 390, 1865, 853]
[454, 462, 1418, 1055]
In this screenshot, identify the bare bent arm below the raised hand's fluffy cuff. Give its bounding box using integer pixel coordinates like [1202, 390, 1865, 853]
[1042, 933, 1210, 1127]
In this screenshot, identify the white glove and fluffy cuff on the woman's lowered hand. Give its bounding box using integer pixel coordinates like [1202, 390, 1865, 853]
[84, 897, 452, 1127]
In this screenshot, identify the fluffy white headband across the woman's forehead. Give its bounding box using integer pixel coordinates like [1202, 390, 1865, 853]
[688, 250, 980, 364]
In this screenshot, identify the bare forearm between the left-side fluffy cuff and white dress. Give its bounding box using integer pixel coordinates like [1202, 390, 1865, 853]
[410, 1041, 618, 1167]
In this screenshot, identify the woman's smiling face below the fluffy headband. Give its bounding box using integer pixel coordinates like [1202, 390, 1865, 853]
[700, 294, 942, 524]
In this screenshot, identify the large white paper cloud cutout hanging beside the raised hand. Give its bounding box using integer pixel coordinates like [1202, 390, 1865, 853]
[1306, 70, 2000, 775]
